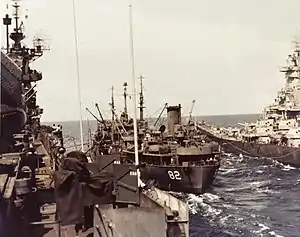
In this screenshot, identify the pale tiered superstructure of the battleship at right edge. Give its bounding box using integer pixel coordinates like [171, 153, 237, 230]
[240, 41, 300, 144]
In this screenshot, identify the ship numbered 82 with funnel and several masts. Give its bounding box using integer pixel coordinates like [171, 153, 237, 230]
[89, 77, 220, 194]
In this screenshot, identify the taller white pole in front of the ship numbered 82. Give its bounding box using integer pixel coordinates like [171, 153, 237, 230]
[129, 4, 140, 181]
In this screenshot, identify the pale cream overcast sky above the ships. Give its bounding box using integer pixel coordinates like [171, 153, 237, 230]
[1, 0, 300, 122]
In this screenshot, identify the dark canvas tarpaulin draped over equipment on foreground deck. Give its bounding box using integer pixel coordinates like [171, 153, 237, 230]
[54, 157, 113, 225]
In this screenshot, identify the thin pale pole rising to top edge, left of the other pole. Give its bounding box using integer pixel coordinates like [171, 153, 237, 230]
[72, 0, 84, 152]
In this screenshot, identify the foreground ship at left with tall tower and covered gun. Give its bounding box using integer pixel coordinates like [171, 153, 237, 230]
[0, 2, 189, 237]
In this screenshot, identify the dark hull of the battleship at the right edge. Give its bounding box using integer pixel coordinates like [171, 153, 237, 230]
[200, 128, 300, 167]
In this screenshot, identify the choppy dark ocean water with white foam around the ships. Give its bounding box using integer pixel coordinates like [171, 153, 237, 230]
[45, 115, 300, 237]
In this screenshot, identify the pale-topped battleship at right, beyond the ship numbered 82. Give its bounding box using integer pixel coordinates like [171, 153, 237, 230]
[197, 41, 300, 167]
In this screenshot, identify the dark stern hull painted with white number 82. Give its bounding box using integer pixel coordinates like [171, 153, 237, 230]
[140, 165, 219, 194]
